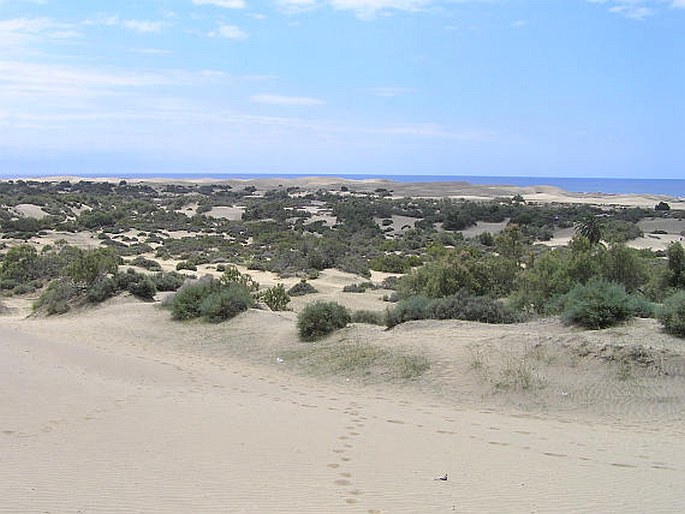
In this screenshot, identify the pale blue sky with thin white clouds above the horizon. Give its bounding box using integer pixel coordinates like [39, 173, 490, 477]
[0, 0, 685, 178]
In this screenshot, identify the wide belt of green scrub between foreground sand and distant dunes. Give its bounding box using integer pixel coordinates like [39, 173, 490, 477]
[0, 180, 685, 333]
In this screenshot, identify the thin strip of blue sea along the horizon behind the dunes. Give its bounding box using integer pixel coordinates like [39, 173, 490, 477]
[5, 173, 685, 197]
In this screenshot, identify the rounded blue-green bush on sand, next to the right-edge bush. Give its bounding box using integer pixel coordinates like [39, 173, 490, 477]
[562, 279, 633, 329]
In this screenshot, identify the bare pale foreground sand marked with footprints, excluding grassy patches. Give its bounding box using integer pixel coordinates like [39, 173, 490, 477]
[0, 299, 685, 513]
